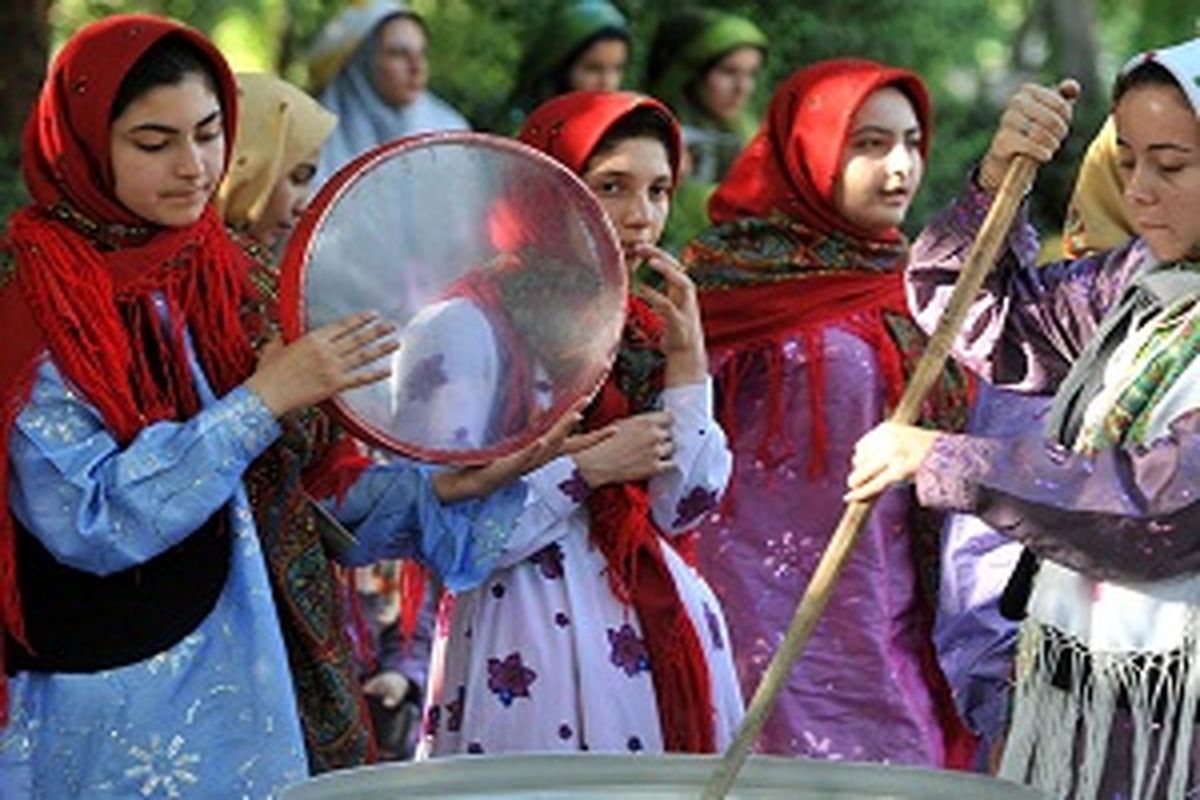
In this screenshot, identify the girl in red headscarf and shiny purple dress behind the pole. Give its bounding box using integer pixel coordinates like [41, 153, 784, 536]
[684, 59, 967, 765]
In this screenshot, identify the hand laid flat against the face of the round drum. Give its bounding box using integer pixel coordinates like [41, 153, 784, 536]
[246, 312, 400, 417]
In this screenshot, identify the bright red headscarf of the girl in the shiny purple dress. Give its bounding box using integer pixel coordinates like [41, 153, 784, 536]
[708, 59, 931, 241]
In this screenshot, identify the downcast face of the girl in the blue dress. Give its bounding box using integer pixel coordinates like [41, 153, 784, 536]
[109, 74, 224, 228]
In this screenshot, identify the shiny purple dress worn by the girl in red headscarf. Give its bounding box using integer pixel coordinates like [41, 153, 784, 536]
[698, 327, 944, 765]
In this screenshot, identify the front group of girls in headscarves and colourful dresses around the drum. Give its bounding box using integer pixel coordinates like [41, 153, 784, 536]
[0, 7, 1200, 798]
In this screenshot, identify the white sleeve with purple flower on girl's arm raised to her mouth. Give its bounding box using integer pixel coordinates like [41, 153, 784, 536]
[650, 378, 733, 533]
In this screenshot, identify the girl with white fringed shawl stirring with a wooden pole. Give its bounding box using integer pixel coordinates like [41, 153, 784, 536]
[848, 40, 1200, 798]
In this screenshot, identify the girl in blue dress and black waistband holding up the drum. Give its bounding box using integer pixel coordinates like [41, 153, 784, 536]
[0, 16, 549, 800]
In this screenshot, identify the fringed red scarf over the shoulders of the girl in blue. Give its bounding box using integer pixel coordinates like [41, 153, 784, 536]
[0, 209, 254, 714]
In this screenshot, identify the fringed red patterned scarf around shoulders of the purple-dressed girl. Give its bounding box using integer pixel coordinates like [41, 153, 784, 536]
[684, 216, 977, 769]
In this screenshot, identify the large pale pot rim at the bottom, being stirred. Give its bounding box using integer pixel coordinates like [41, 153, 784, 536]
[282, 753, 1043, 800]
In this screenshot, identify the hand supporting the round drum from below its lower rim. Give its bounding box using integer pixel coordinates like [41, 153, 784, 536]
[433, 397, 617, 503]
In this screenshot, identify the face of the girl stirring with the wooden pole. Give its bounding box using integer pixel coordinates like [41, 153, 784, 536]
[1114, 85, 1200, 261]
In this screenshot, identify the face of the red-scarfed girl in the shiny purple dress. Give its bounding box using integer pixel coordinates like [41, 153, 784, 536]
[834, 86, 925, 233]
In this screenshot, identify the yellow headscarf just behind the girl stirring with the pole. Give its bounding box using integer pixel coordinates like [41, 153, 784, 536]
[1062, 116, 1134, 258]
